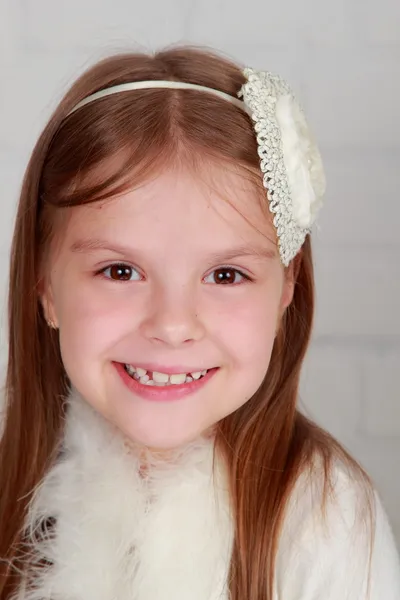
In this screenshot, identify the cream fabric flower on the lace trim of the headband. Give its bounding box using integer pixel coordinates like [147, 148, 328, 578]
[276, 94, 326, 229]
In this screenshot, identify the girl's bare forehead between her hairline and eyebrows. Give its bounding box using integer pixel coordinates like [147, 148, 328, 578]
[61, 164, 276, 252]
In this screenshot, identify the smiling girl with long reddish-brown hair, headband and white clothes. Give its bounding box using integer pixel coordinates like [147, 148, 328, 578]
[0, 48, 400, 600]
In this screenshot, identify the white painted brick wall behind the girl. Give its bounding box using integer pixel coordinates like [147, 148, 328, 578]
[0, 0, 400, 541]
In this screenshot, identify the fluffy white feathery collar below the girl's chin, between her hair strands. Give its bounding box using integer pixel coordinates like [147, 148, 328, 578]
[18, 391, 233, 600]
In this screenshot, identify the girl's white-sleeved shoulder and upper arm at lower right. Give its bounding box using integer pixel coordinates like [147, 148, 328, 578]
[274, 454, 400, 600]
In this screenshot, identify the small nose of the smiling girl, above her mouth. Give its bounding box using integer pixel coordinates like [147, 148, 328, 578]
[141, 290, 205, 348]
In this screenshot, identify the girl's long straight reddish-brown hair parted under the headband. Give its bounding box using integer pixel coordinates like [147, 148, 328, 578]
[0, 47, 376, 600]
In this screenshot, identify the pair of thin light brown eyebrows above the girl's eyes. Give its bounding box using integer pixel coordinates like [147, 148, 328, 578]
[70, 238, 277, 262]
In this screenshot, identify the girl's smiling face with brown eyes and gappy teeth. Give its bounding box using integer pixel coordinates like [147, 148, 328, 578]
[42, 167, 293, 449]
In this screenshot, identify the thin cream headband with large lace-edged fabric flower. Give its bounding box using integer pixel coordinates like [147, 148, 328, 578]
[67, 69, 326, 266]
